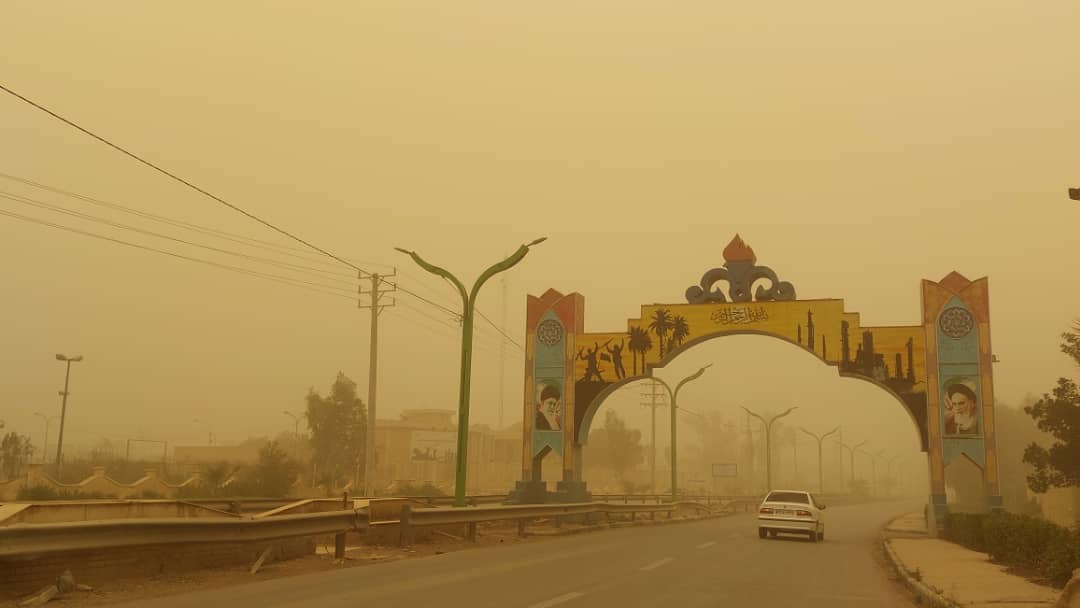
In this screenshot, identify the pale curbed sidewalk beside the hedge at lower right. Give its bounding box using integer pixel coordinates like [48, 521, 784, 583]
[886, 513, 1058, 608]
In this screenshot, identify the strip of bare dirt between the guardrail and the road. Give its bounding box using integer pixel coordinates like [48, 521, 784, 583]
[6, 517, 717, 608]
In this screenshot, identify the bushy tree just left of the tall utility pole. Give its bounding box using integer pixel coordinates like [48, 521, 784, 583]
[305, 371, 367, 483]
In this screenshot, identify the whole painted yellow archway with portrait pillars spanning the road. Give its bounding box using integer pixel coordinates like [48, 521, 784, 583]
[512, 235, 1001, 529]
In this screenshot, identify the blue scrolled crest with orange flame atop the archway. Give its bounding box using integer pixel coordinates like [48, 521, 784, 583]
[686, 234, 795, 303]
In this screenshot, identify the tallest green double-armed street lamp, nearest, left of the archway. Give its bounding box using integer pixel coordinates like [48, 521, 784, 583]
[394, 237, 548, 506]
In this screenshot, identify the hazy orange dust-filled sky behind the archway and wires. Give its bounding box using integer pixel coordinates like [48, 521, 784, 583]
[0, 0, 1080, 462]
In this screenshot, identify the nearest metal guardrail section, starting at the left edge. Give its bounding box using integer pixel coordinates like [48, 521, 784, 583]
[0, 510, 367, 557]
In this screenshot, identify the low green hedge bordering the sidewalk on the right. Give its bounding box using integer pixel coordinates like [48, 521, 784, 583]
[945, 513, 1080, 586]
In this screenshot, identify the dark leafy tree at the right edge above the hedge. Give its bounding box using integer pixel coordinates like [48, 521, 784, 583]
[1024, 324, 1080, 494]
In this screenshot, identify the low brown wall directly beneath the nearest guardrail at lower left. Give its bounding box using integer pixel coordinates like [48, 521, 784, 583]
[0, 538, 315, 599]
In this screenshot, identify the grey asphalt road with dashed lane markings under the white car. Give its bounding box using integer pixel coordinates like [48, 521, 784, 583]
[130, 502, 918, 608]
